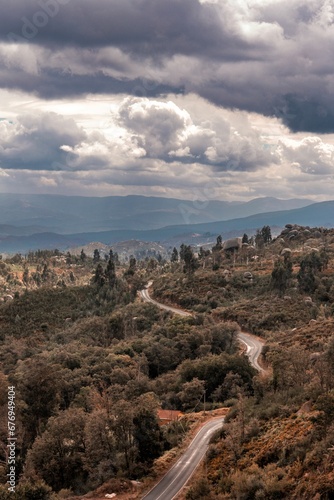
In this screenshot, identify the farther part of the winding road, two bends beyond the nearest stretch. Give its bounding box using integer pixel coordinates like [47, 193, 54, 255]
[139, 281, 265, 373]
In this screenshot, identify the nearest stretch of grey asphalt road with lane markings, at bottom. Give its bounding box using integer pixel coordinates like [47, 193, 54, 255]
[142, 417, 224, 500]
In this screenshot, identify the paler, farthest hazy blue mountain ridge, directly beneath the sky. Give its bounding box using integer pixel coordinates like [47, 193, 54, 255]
[0, 193, 312, 235]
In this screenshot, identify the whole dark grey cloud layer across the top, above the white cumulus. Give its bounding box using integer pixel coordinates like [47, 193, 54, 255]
[0, 0, 334, 133]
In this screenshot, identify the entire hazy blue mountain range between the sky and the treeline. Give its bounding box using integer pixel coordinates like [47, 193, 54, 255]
[0, 195, 334, 253]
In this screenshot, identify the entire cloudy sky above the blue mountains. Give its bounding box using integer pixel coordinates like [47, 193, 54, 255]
[0, 0, 334, 201]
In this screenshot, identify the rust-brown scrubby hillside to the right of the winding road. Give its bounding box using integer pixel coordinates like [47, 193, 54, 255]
[154, 225, 334, 500]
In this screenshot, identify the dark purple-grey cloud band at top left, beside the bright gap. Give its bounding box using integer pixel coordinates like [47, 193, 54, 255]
[0, 0, 250, 60]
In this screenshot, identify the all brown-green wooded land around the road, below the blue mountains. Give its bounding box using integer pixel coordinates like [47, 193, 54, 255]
[0, 225, 334, 500]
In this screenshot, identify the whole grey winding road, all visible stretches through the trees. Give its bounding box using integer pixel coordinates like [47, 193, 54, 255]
[139, 282, 265, 500]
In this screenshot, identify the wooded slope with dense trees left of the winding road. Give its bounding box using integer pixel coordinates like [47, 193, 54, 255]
[0, 248, 254, 499]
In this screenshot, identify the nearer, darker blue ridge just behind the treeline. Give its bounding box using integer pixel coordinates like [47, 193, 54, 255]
[0, 201, 334, 253]
